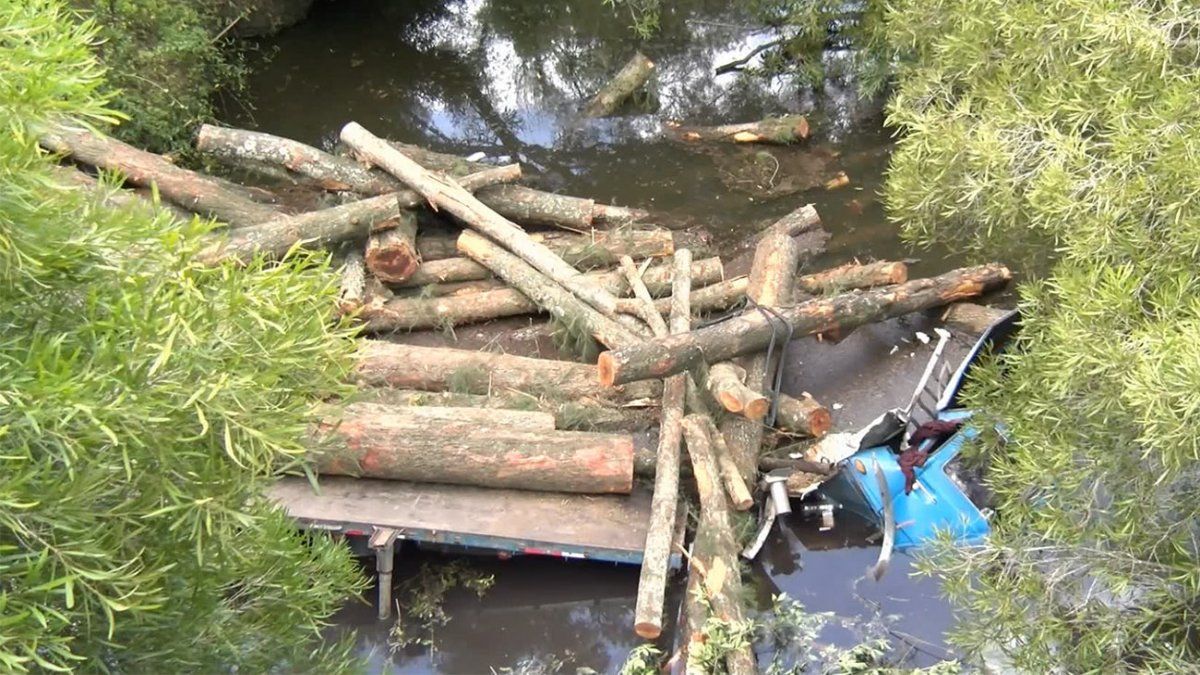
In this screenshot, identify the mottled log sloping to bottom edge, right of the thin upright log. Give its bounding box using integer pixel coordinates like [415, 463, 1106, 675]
[683, 416, 757, 675]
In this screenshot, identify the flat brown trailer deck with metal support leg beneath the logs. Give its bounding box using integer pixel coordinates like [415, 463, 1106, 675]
[270, 476, 685, 619]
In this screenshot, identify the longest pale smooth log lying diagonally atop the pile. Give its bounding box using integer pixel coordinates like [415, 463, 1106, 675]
[342, 123, 617, 317]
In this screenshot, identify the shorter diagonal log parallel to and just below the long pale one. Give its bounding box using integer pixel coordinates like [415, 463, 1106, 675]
[458, 232, 641, 348]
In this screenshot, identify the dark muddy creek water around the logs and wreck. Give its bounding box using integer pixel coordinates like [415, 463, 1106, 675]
[227, 0, 974, 673]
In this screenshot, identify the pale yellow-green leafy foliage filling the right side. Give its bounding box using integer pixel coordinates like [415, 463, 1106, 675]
[887, 0, 1200, 673]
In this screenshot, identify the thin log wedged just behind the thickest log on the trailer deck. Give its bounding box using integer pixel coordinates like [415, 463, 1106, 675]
[354, 387, 659, 432]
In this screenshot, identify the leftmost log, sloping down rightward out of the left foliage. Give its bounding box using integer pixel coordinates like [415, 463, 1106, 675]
[41, 123, 282, 227]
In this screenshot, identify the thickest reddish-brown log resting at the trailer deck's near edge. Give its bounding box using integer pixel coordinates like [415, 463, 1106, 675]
[313, 404, 634, 494]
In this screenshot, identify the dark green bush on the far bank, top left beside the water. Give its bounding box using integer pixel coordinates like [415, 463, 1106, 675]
[73, 0, 246, 151]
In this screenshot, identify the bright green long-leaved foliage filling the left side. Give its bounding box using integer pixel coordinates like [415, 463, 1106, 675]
[0, 0, 360, 673]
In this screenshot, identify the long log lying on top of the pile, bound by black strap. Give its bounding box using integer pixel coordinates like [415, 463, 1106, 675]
[598, 263, 1013, 386]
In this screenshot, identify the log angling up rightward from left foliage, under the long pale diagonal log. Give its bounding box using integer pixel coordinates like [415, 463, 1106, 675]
[198, 165, 521, 264]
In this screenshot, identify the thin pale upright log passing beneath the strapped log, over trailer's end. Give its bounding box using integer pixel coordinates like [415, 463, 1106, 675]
[626, 249, 691, 640]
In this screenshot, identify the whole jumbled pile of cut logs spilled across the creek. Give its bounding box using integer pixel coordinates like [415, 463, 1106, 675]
[54, 118, 1010, 658]
